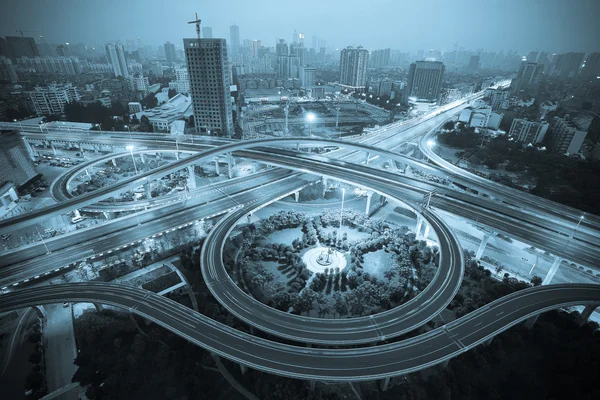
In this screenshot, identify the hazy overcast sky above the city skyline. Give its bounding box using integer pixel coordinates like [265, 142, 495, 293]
[0, 0, 600, 54]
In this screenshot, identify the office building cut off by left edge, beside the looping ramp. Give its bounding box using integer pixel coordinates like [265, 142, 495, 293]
[0, 132, 37, 187]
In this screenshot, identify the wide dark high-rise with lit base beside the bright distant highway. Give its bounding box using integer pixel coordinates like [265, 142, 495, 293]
[403, 61, 446, 104]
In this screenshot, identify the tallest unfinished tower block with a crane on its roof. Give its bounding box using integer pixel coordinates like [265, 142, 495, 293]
[183, 38, 235, 136]
